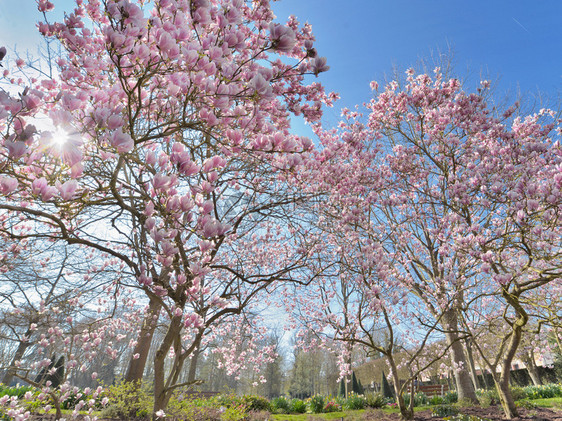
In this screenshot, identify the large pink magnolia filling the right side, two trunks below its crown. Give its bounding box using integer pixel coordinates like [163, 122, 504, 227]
[311, 70, 560, 416]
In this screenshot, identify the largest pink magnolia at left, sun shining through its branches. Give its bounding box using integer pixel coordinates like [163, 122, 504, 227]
[0, 0, 334, 414]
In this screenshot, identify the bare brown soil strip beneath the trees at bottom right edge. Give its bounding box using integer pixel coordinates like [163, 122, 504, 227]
[356, 405, 562, 421]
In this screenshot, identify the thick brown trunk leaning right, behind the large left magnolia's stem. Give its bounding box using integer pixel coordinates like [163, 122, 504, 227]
[125, 299, 162, 383]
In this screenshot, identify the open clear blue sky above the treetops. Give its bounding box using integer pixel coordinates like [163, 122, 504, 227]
[0, 0, 562, 121]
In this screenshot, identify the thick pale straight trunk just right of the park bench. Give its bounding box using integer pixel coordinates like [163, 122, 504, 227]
[442, 309, 478, 403]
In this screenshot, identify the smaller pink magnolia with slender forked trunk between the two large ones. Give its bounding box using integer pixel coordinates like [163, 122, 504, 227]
[292, 218, 460, 419]
